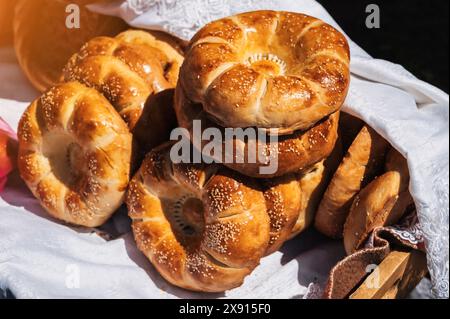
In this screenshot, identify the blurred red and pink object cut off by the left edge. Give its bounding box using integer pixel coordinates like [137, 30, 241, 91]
[0, 117, 17, 192]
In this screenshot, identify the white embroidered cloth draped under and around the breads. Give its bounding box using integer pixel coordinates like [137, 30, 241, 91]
[0, 0, 449, 298]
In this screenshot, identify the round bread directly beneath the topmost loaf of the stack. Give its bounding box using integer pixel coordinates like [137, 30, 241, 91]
[174, 85, 340, 178]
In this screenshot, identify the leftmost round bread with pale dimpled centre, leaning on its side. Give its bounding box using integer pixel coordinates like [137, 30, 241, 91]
[18, 82, 131, 227]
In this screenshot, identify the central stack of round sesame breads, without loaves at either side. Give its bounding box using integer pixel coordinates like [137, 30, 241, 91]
[127, 11, 349, 291]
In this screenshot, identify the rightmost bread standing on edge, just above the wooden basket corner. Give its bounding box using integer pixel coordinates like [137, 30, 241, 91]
[344, 171, 413, 254]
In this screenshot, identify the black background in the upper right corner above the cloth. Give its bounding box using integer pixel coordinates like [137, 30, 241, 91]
[317, 0, 450, 93]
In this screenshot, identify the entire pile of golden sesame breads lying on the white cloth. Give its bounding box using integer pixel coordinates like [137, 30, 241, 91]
[16, 11, 411, 292]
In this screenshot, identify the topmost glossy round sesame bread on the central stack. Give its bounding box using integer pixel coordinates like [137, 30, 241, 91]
[180, 11, 350, 134]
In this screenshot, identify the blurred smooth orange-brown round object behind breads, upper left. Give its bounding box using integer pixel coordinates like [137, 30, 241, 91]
[14, 0, 127, 91]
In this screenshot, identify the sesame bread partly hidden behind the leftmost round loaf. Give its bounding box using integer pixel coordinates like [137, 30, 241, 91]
[63, 31, 183, 129]
